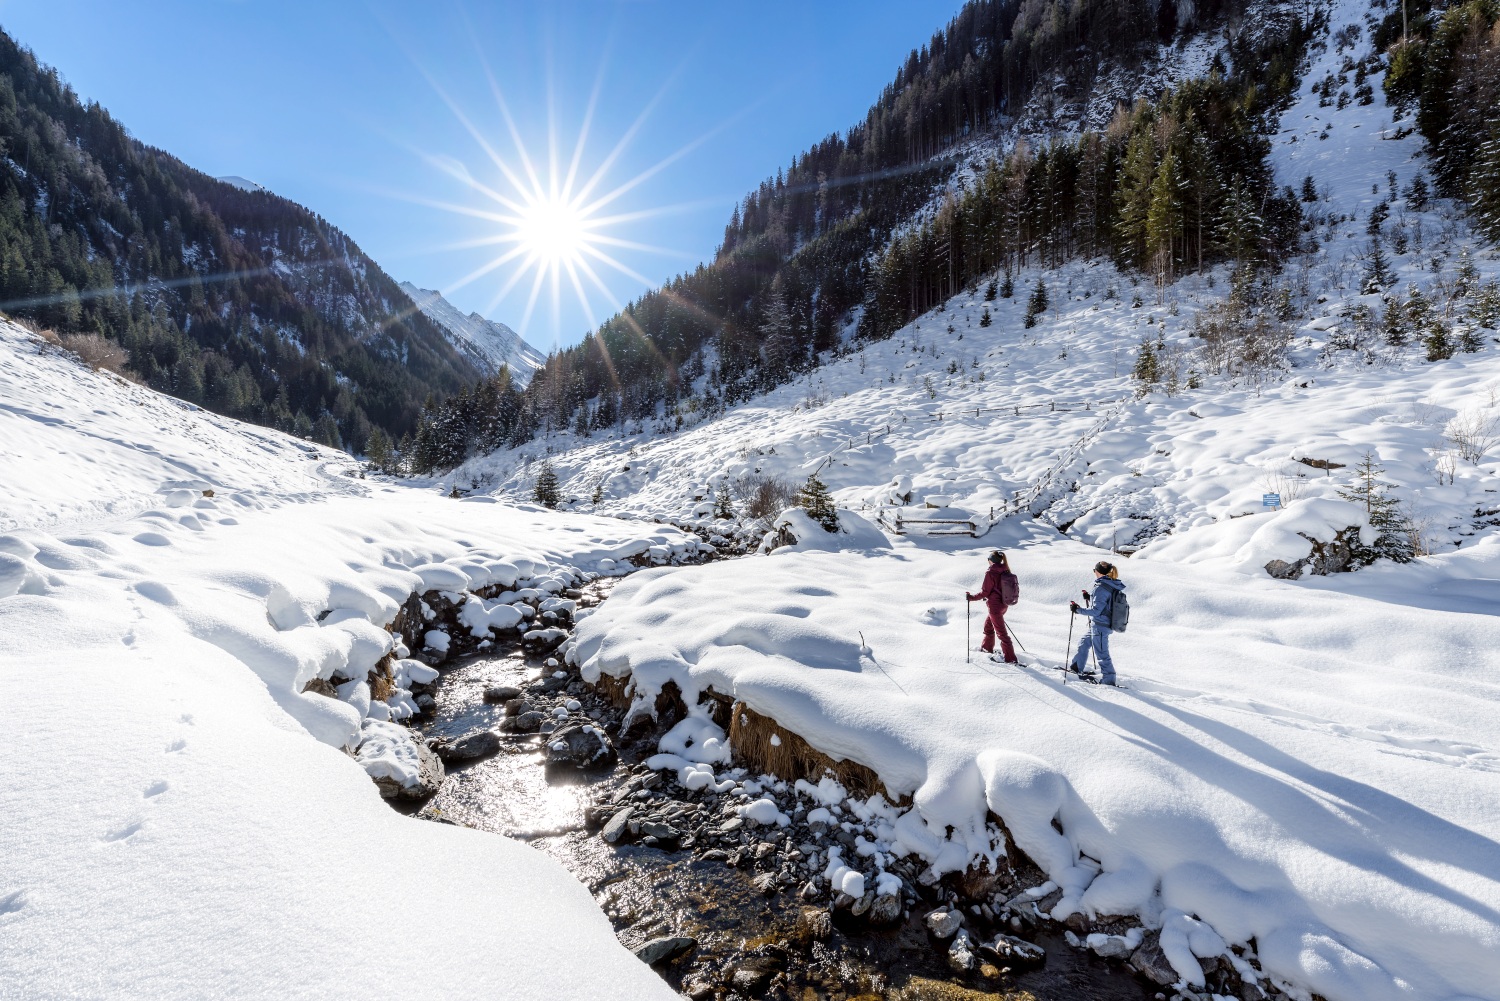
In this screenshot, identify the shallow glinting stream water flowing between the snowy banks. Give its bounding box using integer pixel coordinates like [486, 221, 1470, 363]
[405, 585, 1152, 1001]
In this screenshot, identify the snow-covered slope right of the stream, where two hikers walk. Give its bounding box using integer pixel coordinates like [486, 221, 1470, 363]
[455, 3, 1500, 1001]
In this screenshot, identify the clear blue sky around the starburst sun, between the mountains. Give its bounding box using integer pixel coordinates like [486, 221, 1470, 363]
[0, 0, 962, 350]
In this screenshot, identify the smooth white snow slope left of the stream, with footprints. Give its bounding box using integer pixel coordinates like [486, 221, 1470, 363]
[0, 323, 683, 1001]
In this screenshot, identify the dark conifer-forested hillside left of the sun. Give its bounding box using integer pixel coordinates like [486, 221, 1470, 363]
[0, 33, 479, 450]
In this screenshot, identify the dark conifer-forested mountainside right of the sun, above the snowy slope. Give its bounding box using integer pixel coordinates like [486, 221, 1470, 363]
[411, 0, 1319, 470]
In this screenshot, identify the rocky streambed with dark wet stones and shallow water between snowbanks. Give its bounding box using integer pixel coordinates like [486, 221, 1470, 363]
[387, 579, 1230, 1001]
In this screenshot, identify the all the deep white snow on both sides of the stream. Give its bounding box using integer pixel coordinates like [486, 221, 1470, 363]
[0, 3, 1500, 1001]
